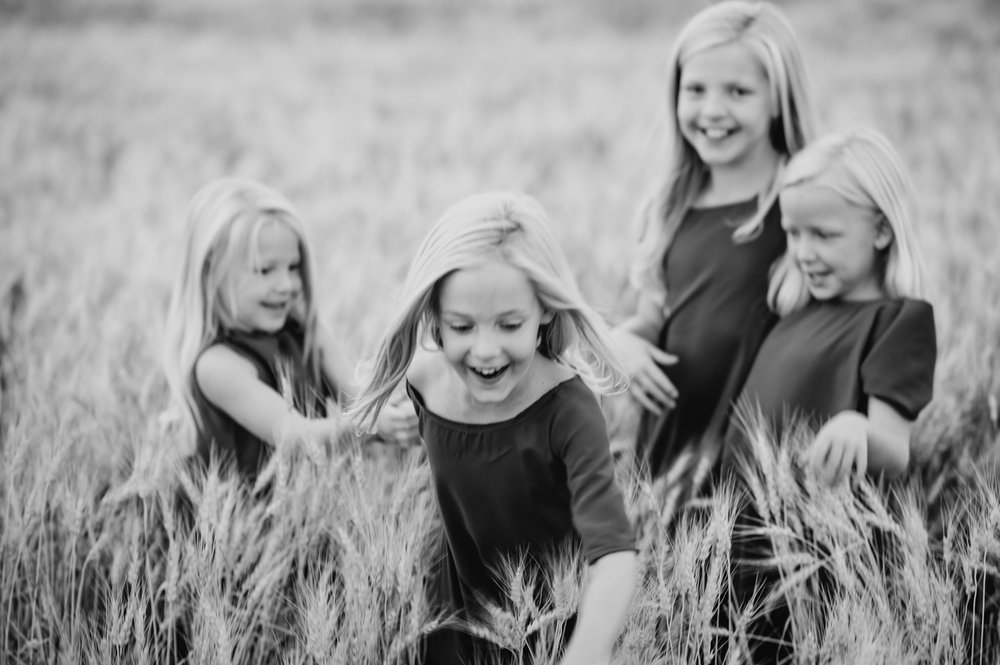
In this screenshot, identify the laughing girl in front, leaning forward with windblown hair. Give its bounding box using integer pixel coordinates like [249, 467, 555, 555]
[353, 193, 636, 664]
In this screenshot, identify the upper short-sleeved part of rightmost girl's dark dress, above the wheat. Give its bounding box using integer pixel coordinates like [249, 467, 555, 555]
[725, 298, 937, 466]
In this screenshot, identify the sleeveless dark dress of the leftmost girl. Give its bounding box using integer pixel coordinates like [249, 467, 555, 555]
[191, 319, 336, 484]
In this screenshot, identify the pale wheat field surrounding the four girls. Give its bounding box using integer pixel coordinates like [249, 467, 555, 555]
[0, 0, 1000, 665]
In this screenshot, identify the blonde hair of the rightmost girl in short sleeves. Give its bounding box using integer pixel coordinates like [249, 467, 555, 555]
[767, 127, 924, 316]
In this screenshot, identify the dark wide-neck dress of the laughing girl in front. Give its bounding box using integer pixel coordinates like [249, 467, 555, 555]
[407, 377, 635, 665]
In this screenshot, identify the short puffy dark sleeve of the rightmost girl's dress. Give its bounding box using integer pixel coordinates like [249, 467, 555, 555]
[861, 300, 937, 420]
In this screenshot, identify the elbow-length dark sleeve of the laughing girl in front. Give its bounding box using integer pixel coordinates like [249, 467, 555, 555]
[552, 383, 635, 563]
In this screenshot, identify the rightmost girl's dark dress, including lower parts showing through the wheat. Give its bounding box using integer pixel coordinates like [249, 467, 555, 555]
[722, 298, 937, 663]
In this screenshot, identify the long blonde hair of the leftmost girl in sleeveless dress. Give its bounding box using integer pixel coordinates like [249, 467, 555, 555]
[163, 178, 320, 434]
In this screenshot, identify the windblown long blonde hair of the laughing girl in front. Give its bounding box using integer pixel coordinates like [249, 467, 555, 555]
[348, 192, 627, 430]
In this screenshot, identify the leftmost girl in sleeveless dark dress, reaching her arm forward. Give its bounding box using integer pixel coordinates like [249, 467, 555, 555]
[164, 179, 416, 483]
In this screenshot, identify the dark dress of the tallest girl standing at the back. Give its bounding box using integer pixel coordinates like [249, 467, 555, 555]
[636, 198, 785, 478]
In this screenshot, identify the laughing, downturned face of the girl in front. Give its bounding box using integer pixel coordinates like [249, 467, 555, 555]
[438, 259, 552, 406]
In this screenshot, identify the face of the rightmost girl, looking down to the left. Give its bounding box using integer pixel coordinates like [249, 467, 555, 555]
[779, 183, 892, 301]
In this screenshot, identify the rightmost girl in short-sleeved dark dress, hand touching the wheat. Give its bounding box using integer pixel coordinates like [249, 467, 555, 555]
[727, 129, 937, 483]
